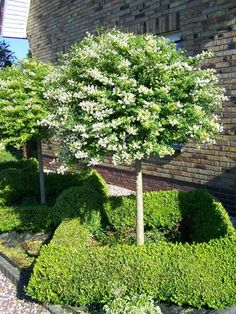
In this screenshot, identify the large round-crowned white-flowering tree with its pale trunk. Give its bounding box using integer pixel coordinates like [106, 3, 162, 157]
[44, 30, 224, 245]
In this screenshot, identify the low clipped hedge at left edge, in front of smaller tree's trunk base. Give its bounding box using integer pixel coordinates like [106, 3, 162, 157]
[0, 205, 50, 233]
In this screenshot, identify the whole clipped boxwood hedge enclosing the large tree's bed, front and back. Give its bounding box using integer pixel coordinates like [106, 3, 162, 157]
[27, 188, 236, 308]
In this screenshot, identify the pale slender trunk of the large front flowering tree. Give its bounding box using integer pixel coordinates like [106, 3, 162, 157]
[135, 160, 144, 246]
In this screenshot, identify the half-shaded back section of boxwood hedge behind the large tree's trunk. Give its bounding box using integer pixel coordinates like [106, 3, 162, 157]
[105, 190, 234, 242]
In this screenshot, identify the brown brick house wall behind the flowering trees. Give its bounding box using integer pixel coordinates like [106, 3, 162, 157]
[28, 0, 236, 214]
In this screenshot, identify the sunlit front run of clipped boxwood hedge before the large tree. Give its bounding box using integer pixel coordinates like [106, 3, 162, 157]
[27, 234, 236, 308]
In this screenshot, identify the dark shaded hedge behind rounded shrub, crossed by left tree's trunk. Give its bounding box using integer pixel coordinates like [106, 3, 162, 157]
[0, 164, 108, 205]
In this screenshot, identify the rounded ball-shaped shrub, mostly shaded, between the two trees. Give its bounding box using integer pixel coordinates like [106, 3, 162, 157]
[50, 185, 103, 232]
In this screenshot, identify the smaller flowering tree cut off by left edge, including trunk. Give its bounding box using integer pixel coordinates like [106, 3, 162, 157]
[0, 59, 51, 204]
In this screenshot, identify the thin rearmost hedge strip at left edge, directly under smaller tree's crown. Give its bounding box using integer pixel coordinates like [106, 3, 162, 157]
[0, 158, 38, 172]
